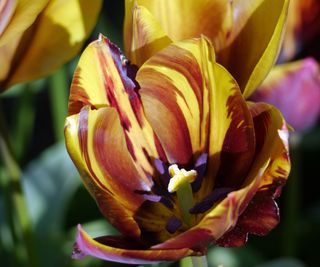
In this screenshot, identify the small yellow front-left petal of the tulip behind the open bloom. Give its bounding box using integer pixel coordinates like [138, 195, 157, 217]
[124, 5, 172, 66]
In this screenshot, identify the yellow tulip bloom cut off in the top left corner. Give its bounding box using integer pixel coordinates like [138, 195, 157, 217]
[0, 0, 102, 90]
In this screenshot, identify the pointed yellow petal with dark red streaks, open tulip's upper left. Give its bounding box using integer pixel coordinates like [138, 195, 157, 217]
[69, 35, 159, 180]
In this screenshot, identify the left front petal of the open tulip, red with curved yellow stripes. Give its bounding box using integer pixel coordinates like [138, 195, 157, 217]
[65, 106, 151, 236]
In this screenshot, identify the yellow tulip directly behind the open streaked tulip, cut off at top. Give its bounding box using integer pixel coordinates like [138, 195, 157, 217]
[124, 0, 289, 98]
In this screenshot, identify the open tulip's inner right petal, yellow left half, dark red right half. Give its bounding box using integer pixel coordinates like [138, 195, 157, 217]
[196, 64, 255, 201]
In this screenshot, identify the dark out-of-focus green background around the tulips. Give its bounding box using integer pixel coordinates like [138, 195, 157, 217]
[0, 0, 320, 267]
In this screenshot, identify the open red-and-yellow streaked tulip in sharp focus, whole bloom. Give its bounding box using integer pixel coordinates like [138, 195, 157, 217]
[65, 36, 290, 264]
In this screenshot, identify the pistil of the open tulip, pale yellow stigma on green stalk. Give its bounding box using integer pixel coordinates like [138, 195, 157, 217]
[168, 164, 197, 226]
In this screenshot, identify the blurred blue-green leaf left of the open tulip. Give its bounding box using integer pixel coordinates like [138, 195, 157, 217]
[22, 143, 81, 267]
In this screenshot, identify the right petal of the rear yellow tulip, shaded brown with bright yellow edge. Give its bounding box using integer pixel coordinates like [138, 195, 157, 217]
[219, 0, 289, 98]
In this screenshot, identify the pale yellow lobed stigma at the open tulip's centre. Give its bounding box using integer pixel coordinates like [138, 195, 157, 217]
[168, 164, 197, 193]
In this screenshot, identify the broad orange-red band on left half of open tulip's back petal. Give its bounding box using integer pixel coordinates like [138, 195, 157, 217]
[139, 69, 192, 164]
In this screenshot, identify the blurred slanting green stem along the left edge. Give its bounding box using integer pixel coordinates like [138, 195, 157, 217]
[0, 100, 38, 267]
